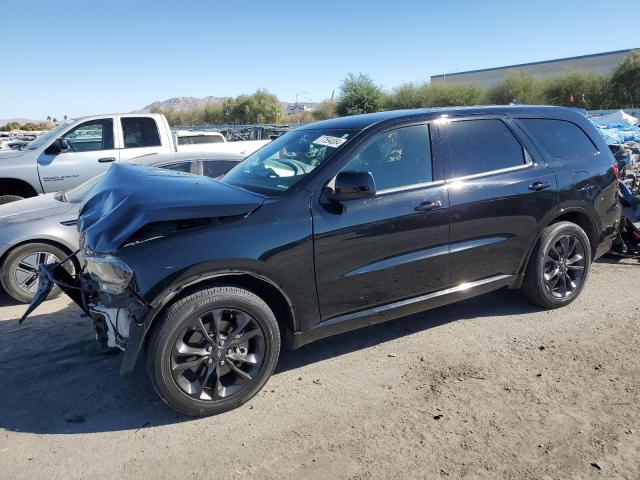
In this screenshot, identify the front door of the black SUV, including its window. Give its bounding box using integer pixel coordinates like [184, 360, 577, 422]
[312, 123, 449, 320]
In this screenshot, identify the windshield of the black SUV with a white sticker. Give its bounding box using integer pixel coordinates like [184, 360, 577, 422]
[222, 129, 358, 195]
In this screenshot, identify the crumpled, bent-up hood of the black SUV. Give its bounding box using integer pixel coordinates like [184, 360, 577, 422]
[78, 163, 265, 253]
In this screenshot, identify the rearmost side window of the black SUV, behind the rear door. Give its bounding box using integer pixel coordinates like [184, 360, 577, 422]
[518, 118, 598, 158]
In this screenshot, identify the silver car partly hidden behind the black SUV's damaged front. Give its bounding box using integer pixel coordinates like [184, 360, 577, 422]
[0, 153, 244, 303]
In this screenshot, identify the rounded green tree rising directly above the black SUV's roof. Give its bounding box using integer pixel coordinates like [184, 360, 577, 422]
[336, 73, 385, 116]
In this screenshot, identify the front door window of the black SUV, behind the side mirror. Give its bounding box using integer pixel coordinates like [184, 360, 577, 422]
[342, 125, 433, 190]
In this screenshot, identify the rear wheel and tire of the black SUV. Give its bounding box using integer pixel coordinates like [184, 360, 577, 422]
[522, 222, 591, 309]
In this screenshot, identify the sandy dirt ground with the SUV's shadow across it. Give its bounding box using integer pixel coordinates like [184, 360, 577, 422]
[0, 260, 640, 479]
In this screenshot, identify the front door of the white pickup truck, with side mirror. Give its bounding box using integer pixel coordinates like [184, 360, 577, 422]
[38, 117, 119, 193]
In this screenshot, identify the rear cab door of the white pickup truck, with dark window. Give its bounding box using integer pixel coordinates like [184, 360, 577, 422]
[118, 116, 170, 162]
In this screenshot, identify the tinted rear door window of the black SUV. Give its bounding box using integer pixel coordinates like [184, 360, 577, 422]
[445, 120, 525, 178]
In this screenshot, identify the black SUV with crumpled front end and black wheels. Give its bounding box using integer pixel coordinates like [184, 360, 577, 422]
[25, 106, 621, 415]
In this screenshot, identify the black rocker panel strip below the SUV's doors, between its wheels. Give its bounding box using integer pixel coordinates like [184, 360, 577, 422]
[287, 275, 516, 349]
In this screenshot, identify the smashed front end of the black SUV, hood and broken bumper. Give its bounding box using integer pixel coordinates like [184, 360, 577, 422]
[20, 164, 265, 374]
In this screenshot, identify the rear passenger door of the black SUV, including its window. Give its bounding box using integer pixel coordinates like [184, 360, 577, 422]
[441, 117, 558, 285]
